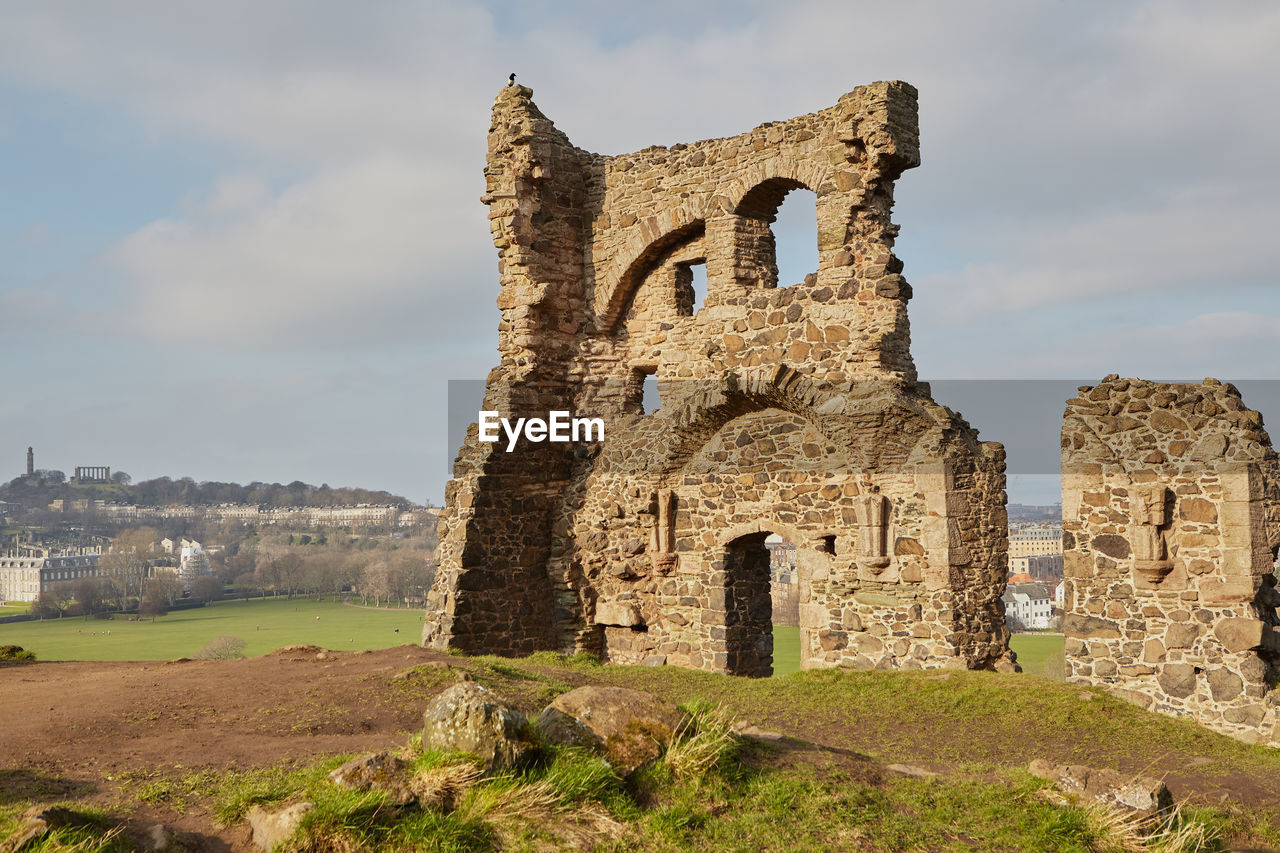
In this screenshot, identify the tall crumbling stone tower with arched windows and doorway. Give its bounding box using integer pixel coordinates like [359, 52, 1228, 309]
[424, 82, 1012, 675]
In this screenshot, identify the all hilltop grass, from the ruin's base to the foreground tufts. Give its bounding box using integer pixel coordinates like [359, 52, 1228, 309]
[17, 652, 1280, 853]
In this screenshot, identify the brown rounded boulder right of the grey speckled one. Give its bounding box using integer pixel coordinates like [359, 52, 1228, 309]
[538, 686, 689, 774]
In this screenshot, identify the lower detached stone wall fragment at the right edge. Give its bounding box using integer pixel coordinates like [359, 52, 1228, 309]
[1062, 375, 1280, 744]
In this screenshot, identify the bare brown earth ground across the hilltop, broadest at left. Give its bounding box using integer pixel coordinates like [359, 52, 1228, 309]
[0, 646, 1280, 850]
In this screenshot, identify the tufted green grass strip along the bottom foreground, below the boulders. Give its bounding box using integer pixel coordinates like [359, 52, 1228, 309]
[165, 702, 1267, 853]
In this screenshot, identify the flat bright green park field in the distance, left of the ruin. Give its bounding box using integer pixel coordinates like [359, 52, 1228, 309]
[0, 598, 422, 661]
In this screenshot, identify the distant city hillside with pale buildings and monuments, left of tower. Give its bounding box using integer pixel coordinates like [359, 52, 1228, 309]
[0, 447, 438, 603]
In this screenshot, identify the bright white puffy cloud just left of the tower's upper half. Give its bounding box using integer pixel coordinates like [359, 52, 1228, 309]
[108, 156, 497, 350]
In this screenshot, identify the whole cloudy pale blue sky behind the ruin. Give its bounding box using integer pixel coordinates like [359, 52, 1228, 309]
[0, 0, 1280, 503]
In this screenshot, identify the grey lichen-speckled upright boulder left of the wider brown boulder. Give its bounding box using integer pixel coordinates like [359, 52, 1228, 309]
[422, 681, 539, 771]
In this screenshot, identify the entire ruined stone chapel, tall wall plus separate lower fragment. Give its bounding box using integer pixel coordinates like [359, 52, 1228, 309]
[424, 82, 1280, 743]
